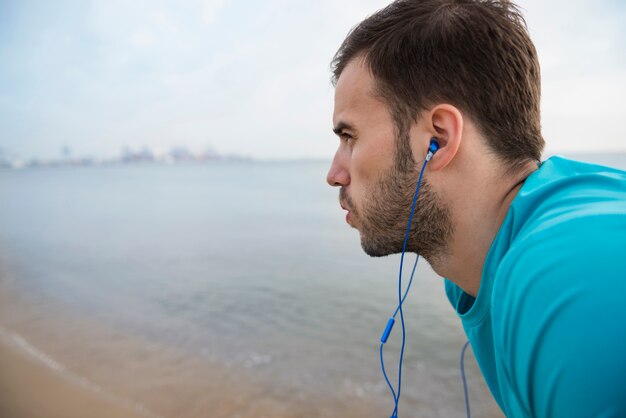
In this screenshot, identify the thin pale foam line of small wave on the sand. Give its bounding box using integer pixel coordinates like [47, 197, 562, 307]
[0, 327, 163, 418]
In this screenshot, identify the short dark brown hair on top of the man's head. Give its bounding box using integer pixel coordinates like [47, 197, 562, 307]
[331, 0, 544, 171]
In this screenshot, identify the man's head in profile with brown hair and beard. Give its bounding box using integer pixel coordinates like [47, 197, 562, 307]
[328, 0, 543, 258]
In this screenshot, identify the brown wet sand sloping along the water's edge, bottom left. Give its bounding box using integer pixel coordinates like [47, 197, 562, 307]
[0, 272, 386, 418]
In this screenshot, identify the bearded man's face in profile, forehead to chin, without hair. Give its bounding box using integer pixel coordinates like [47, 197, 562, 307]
[327, 59, 451, 259]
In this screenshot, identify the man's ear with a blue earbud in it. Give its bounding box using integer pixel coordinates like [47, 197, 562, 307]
[420, 104, 463, 170]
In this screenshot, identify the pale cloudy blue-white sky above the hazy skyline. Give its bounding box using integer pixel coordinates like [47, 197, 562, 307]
[0, 0, 626, 159]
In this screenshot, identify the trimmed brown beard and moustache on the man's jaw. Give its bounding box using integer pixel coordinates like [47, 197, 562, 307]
[340, 135, 452, 265]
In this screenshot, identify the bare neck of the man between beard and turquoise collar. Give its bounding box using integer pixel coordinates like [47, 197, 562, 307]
[433, 163, 537, 297]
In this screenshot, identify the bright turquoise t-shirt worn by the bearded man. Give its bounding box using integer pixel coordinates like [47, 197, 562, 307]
[445, 157, 626, 418]
